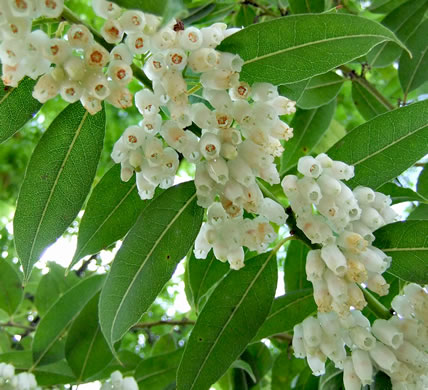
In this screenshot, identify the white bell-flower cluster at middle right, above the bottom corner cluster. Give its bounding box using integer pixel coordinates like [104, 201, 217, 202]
[282, 154, 397, 317]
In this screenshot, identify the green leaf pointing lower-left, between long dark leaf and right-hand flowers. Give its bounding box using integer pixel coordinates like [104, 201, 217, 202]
[253, 289, 317, 341]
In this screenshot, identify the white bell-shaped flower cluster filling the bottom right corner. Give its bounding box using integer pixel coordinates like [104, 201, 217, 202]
[293, 284, 428, 390]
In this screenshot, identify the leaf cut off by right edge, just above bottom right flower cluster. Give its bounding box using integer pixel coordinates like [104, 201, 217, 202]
[374, 220, 428, 284]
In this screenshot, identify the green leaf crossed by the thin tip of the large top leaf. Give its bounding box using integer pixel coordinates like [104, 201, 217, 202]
[367, 0, 428, 67]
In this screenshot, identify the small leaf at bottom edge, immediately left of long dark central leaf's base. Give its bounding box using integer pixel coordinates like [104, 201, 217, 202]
[134, 348, 183, 390]
